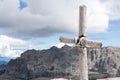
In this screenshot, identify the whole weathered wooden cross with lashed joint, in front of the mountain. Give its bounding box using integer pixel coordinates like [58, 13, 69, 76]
[60, 5, 102, 80]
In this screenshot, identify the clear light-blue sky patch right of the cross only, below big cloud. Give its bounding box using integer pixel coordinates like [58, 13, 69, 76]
[89, 20, 120, 47]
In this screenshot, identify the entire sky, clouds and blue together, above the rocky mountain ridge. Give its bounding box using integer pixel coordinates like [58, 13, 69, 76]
[0, 0, 120, 58]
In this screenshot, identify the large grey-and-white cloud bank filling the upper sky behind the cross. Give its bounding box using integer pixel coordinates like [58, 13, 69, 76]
[0, 0, 120, 38]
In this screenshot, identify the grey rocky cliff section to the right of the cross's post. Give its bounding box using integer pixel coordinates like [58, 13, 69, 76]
[88, 47, 120, 77]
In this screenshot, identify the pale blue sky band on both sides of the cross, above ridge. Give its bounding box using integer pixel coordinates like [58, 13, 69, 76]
[40, 20, 120, 49]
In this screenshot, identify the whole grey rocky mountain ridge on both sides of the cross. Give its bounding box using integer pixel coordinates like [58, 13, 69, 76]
[0, 45, 120, 80]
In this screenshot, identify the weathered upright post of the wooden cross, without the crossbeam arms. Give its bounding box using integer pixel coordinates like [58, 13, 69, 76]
[78, 5, 88, 80]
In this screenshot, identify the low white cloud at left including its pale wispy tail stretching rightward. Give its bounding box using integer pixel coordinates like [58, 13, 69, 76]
[0, 35, 45, 58]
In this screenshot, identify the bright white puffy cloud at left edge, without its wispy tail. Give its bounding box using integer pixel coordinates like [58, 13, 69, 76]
[0, 35, 26, 58]
